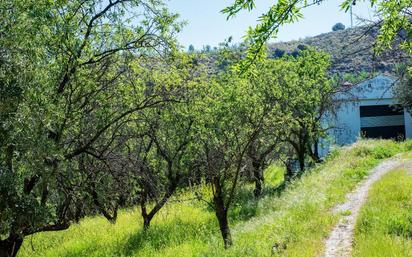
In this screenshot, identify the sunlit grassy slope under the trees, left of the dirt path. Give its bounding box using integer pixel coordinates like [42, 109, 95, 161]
[19, 141, 412, 257]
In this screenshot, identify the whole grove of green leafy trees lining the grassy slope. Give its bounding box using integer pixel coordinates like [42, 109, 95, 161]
[0, 0, 408, 257]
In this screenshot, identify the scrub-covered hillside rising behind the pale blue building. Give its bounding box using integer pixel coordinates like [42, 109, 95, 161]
[269, 27, 410, 73]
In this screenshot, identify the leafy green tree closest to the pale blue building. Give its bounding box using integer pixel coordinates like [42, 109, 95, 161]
[278, 49, 336, 171]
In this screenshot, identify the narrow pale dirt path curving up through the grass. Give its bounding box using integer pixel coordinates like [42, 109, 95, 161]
[324, 157, 403, 257]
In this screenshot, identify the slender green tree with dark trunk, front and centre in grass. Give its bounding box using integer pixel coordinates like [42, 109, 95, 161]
[192, 67, 268, 248]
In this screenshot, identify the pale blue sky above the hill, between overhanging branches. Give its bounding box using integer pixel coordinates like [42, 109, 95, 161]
[167, 0, 374, 49]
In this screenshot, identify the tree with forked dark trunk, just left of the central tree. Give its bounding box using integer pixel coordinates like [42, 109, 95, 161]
[127, 54, 207, 229]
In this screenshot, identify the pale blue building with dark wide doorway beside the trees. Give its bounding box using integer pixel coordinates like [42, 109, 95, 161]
[321, 75, 412, 154]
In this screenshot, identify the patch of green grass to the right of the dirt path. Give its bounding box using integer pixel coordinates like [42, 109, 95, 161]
[353, 165, 412, 257]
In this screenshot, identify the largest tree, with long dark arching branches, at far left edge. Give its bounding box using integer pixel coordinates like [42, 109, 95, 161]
[0, 0, 180, 256]
